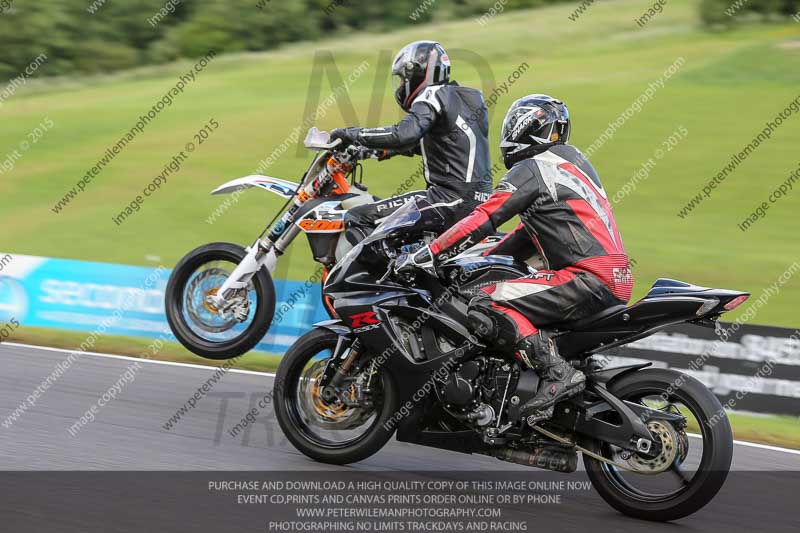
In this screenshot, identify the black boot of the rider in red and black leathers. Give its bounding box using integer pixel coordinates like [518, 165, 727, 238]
[516, 331, 586, 425]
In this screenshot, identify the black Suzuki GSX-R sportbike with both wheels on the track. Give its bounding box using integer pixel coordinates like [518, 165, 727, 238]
[273, 202, 748, 521]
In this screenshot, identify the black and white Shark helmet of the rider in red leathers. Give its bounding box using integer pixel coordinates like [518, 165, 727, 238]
[500, 94, 570, 168]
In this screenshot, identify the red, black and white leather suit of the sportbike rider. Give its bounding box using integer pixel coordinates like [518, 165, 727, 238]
[430, 144, 633, 340]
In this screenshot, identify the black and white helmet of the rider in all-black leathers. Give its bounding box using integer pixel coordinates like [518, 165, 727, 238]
[392, 41, 450, 111]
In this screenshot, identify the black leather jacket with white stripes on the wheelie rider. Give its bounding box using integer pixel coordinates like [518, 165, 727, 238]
[358, 83, 492, 209]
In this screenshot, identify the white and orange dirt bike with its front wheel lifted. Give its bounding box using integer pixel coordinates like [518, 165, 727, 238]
[165, 128, 501, 359]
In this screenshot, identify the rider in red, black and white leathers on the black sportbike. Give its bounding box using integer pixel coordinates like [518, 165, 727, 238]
[395, 95, 633, 424]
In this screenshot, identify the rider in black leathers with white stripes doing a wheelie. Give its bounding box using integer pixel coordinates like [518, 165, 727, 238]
[331, 41, 492, 244]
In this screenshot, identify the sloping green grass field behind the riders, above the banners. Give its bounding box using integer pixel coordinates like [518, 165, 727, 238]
[0, 0, 800, 327]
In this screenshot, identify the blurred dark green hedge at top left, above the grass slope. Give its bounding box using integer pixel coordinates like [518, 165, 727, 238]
[0, 0, 563, 79]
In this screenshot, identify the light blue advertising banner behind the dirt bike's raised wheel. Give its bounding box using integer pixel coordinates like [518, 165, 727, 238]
[0, 254, 328, 353]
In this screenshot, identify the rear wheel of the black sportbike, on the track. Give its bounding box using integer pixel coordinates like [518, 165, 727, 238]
[584, 369, 733, 521]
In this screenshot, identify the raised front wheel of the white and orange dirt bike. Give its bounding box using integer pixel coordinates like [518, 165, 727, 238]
[164, 242, 275, 360]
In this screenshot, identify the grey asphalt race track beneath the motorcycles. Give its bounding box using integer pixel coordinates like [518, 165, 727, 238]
[0, 344, 800, 532]
